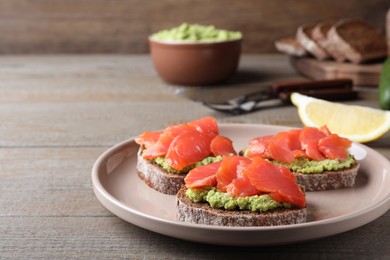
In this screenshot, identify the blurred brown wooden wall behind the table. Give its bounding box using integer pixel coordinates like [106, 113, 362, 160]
[0, 0, 390, 54]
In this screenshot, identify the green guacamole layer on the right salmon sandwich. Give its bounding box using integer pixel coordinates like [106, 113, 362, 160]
[271, 154, 356, 174]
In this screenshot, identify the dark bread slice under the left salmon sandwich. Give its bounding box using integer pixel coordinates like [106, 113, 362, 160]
[137, 148, 186, 195]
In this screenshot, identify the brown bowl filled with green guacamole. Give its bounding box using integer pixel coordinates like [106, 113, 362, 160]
[149, 23, 242, 86]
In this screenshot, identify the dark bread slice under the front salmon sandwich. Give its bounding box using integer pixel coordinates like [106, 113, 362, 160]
[176, 186, 306, 227]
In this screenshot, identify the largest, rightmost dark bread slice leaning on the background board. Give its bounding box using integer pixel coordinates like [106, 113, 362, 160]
[328, 19, 387, 64]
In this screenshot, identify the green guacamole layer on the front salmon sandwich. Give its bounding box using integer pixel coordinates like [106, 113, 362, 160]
[186, 188, 292, 212]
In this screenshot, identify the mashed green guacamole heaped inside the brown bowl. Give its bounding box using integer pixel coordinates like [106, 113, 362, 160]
[152, 23, 242, 42]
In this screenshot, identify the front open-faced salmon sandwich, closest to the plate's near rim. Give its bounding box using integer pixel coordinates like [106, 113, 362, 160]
[176, 156, 306, 227]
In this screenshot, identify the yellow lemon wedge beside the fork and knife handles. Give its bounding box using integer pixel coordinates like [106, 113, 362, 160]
[291, 93, 390, 143]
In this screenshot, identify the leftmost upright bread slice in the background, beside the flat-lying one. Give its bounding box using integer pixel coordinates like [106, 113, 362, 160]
[296, 24, 329, 60]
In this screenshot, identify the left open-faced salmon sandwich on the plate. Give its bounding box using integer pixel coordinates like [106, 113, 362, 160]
[135, 117, 236, 195]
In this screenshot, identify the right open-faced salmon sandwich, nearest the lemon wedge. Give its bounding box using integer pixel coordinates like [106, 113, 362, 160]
[241, 126, 359, 191]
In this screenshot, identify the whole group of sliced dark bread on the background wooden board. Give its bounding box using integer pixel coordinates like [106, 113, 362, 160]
[275, 17, 390, 64]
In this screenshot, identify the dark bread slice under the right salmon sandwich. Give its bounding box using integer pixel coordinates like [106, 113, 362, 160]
[293, 162, 360, 191]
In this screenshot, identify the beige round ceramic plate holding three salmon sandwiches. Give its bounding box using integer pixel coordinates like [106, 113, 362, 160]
[92, 124, 390, 245]
